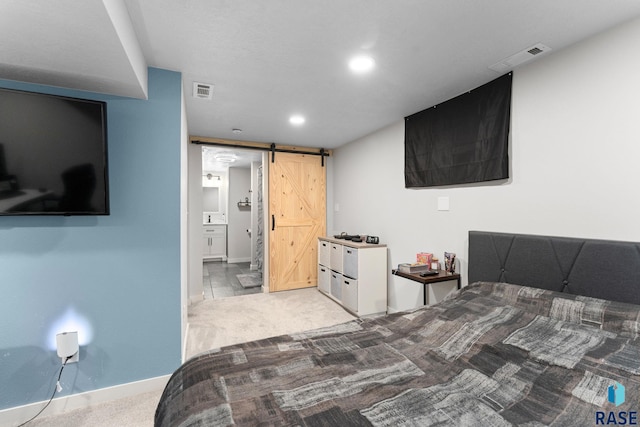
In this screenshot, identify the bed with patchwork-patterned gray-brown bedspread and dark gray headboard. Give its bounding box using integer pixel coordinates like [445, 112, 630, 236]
[155, 231, 640, 427]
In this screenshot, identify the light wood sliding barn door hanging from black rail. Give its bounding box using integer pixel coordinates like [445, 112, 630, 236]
[269, 153, 326, 292]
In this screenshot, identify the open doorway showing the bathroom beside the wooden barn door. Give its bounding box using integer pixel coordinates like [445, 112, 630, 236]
[202, 146, 266, 299]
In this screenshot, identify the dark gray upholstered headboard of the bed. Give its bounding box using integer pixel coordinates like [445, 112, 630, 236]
[469, 231, 640, 304]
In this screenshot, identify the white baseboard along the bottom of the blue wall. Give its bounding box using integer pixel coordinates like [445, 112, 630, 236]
[0, 375, 171, 426]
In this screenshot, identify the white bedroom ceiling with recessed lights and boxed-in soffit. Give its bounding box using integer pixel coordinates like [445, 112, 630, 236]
[0, 0, 640, 148]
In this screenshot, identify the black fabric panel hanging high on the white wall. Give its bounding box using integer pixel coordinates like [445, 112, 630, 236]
[404, 73, 512, 188]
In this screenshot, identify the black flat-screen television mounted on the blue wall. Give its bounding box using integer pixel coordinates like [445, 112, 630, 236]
[0, 88, 109, 215]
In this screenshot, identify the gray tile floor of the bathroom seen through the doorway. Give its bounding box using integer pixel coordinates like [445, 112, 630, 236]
[202, 260, 262, 299]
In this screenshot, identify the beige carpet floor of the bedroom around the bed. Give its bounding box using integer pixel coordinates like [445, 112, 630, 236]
[23, 288, 354, 427]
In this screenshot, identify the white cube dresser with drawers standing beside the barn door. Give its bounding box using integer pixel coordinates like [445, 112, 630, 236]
[318, 237, 388, 316]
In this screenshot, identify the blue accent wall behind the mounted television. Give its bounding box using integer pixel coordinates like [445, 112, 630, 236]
[0, 68, 181, 409]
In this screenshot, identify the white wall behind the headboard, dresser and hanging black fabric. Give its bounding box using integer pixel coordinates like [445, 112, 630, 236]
[328, 20, 640, 310]
